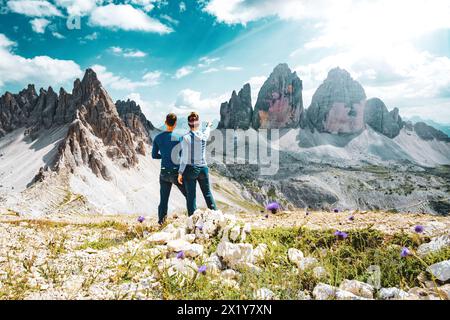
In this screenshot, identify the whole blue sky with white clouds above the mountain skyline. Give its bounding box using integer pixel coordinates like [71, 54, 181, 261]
[0, 0, 450, 124]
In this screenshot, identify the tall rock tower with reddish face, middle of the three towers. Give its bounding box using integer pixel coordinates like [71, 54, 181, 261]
[253, 63, 303, 129]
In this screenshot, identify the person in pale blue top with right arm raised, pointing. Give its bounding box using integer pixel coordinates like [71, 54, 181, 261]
[178, 112, 216, 216]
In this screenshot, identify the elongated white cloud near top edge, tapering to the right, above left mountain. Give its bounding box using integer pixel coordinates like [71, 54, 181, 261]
[89, 4, 173, 34]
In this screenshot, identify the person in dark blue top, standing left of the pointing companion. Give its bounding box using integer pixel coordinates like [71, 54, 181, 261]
[152, 113, 186, 225]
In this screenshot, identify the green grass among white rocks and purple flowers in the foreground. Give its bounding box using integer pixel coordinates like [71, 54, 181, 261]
[156, 228, 450, 299]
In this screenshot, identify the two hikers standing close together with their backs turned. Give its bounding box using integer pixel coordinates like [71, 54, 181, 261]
[152, 112, 216, 225]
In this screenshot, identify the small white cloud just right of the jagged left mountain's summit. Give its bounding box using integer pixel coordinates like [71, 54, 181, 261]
[91, 64, 161, 91]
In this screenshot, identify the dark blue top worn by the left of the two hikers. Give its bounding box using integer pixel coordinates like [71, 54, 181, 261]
[152, 131, 182, 170]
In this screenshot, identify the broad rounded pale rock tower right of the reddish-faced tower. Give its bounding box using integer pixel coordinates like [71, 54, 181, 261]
[307, 68, 366, 134]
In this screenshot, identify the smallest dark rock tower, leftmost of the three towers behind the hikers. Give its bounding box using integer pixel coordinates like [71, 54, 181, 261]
[218, 83, 253, 130]
